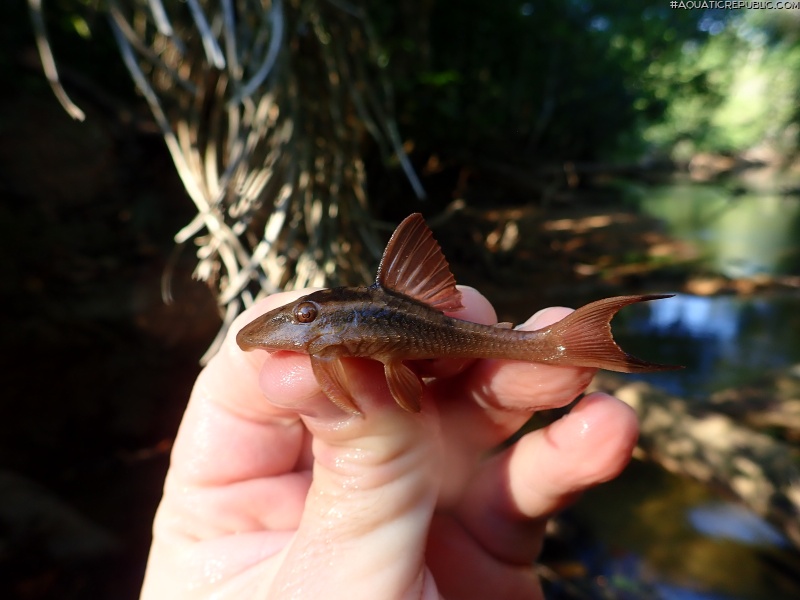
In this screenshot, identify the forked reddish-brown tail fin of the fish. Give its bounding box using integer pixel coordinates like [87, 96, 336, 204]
[546, 294, 683, 373]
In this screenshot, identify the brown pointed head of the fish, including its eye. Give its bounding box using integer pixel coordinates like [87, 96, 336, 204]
[236, 289, 354, 354]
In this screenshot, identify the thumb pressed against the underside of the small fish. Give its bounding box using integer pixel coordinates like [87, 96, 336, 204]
[261, 353, 440, 600]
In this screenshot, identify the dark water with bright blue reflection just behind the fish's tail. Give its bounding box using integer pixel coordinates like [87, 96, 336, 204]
[614, 292, 800, 400]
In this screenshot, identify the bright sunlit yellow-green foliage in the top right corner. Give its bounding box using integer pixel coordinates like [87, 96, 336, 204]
[645, 11, 800, 155]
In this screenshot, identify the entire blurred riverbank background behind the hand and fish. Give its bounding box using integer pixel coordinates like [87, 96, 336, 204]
[0, 0, 800, 599]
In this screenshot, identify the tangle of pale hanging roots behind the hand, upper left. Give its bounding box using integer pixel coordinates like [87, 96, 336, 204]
[29, 0, 424, 362]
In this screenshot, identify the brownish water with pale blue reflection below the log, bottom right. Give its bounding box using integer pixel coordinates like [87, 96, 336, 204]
[575, 463, 800, 600]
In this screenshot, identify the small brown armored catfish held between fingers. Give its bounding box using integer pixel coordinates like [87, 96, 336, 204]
[236, 214, 680, 414]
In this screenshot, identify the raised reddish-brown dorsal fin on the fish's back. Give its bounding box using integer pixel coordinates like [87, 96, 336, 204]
[375, 213, 464, 311]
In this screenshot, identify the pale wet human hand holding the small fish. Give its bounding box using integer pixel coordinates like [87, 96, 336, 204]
[142, 288, 638, 600]
